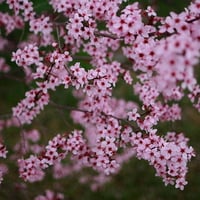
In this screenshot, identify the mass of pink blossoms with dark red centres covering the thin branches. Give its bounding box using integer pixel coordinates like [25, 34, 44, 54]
[0, 0, 200, 196]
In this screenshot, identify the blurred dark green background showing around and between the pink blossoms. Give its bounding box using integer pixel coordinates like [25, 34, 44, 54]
[0, 0, 200, 200]
